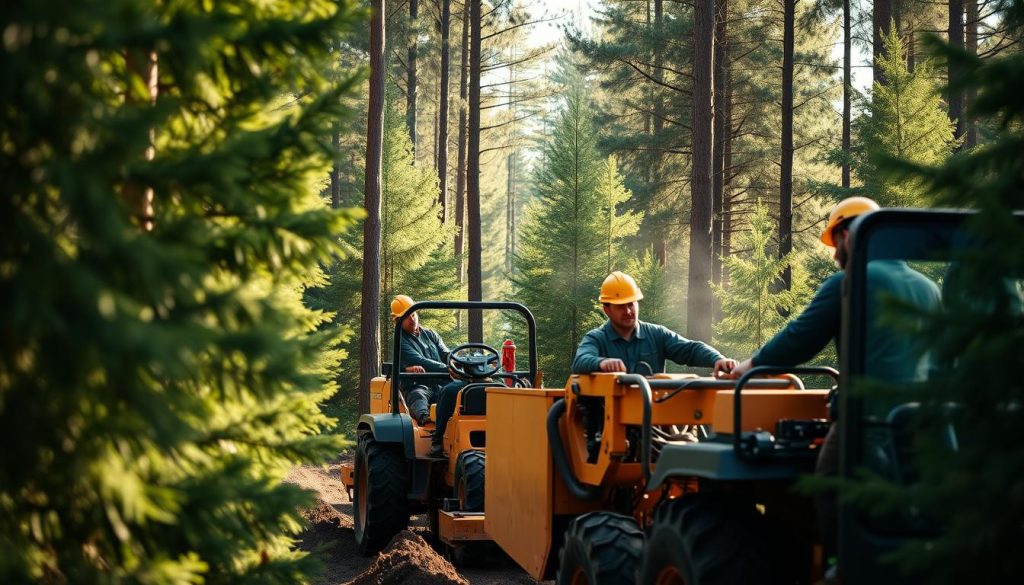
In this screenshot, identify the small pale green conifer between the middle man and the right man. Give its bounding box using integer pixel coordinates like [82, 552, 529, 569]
[712, 202, 810, 356]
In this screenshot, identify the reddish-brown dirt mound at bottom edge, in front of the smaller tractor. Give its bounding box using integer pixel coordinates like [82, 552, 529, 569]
[348, 531, 469, 585]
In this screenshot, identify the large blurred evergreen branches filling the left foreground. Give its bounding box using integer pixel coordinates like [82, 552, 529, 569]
[0, 0, 366, 584]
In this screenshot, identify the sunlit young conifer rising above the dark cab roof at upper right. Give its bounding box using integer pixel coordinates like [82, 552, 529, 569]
[852, 27, 956, 207]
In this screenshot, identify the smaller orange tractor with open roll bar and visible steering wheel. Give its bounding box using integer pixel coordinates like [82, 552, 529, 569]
[341, 301, 541, 562]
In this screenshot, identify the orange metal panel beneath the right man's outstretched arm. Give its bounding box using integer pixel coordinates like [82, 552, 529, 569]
[712, 390, 828, 433]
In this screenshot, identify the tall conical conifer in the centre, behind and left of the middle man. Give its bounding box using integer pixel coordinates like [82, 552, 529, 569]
[512, 85, 640, 384]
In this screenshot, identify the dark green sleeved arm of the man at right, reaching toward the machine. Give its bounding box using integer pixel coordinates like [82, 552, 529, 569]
[751, 273, 843, 366]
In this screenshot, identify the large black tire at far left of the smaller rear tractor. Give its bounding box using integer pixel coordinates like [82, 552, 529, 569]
[352, 432, 409, 555]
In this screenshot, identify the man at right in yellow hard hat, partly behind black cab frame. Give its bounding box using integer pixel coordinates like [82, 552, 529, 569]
[730, 197, 940, 573]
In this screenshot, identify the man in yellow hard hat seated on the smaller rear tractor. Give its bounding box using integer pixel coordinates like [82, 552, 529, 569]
[391, 294, 449, 426]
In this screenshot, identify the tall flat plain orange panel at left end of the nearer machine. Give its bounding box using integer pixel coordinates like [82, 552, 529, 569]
[483, 388, 564, 580]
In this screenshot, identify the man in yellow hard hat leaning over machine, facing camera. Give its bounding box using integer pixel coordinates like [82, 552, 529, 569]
[572, 270, 736, 377]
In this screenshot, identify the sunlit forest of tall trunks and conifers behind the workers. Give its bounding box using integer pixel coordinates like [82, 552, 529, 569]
[306, 0, 1017, 428]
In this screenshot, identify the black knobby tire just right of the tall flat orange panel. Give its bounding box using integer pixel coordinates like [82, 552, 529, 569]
[556, 512, 644, 585]
